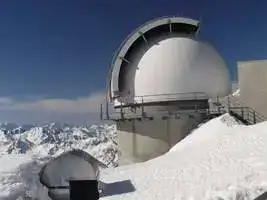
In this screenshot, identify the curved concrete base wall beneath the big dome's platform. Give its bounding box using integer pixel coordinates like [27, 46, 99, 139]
[117, 113, 205, 164]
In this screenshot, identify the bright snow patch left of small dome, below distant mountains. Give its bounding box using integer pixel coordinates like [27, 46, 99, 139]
[0, 154, 49, 200]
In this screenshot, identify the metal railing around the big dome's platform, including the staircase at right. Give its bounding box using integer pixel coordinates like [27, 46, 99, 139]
[100, 92, 266, 125]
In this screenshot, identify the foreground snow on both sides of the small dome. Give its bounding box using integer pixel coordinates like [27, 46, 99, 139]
[0, 114, 267, 200]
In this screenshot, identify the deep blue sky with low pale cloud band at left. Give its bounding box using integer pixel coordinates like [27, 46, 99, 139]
[0, 0, 267, 123]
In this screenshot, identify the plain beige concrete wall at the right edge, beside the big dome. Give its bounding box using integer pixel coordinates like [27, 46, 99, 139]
[238, 60, 267, 117]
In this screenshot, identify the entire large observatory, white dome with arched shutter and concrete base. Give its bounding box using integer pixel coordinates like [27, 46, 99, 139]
[103, 17, 231, 164]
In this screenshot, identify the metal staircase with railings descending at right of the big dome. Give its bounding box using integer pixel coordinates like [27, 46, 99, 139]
[210, 95, 266, 125]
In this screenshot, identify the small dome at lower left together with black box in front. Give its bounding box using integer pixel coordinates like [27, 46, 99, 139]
[39, 149, 106, 200]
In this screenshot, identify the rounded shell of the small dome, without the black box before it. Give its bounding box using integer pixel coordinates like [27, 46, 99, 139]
[40, 149, 106, 188]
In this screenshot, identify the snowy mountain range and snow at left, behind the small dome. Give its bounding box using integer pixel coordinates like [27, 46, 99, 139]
[0, 123, 117, 200]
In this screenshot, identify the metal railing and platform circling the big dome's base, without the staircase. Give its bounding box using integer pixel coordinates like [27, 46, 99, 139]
[100, 92, 208, 120]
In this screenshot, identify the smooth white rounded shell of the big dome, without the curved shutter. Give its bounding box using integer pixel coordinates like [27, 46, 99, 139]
[135, 37, 230, 100]
